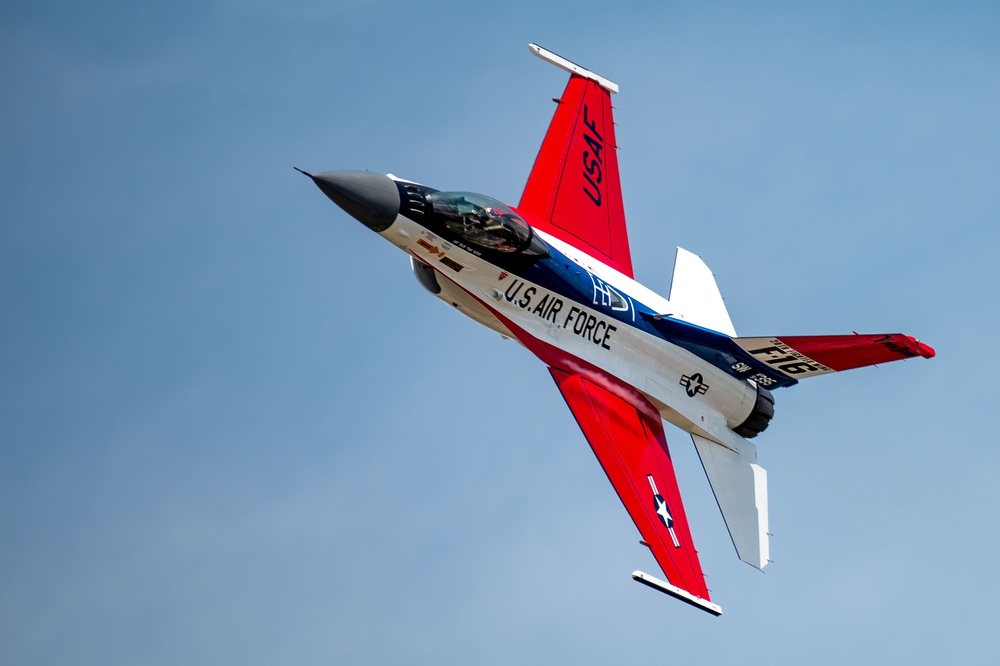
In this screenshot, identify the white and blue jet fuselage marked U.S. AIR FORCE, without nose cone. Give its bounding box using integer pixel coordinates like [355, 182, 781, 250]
[368, 178, 759, 443]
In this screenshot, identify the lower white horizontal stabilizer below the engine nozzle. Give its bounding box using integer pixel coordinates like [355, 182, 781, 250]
[691, 434, 770, 571]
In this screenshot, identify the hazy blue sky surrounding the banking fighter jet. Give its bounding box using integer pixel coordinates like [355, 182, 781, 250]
[0, 0, 1000, 665]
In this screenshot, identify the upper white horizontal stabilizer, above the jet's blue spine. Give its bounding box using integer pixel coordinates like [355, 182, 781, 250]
[670, 247, 736, 338]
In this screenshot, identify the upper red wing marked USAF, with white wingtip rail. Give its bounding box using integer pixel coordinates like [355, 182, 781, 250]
[518, 44, 633, 277]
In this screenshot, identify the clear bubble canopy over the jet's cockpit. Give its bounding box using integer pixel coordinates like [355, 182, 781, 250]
[427, 192, 532, 253]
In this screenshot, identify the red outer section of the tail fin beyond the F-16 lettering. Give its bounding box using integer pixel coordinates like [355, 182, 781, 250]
[778, 333, 934, 371]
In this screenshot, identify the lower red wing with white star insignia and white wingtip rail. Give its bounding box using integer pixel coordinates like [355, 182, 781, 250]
[549, 367, 722, 615]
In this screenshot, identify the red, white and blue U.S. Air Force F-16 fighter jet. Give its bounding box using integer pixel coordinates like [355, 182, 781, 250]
[302, 44, 934, 615]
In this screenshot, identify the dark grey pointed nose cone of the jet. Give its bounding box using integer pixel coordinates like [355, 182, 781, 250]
[306, 171, 399, 231]
